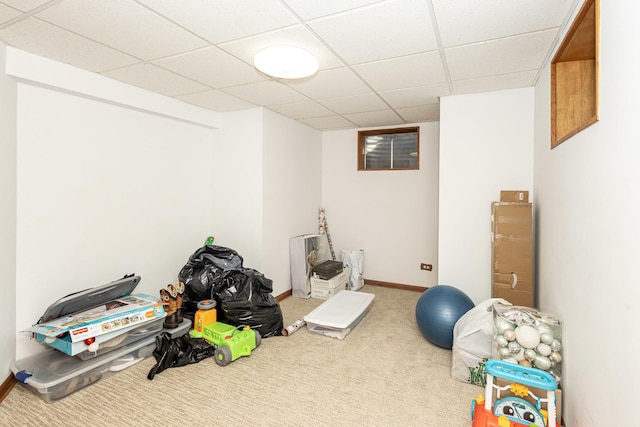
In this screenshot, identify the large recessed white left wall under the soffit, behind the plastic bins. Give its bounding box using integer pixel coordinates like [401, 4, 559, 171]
[13, 67, 214, 358]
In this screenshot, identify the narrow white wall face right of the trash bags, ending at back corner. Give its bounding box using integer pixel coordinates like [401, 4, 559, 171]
[262, 110, 322, 295]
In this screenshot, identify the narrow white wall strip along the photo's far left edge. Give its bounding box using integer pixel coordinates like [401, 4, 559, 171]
[0, 43, 16, 382]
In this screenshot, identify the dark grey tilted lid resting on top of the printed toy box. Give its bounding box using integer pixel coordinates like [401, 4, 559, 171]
[38, 274, 141, 323]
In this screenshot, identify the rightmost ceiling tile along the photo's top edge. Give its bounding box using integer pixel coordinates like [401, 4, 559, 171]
[432, 0, 574, 47]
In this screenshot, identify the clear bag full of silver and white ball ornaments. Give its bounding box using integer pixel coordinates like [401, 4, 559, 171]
[492, 302, 562, 386]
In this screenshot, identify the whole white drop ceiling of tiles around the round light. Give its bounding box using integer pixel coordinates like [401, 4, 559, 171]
[0, 0, 582, 130]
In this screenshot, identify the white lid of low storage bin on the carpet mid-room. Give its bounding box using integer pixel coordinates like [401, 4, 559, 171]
[304, 291, 375, 329]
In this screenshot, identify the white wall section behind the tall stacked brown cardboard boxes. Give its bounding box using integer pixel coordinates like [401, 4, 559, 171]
[438, 88, 534, 304]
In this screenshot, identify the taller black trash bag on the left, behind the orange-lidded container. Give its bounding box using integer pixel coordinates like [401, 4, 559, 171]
[178, 245, 243, 320]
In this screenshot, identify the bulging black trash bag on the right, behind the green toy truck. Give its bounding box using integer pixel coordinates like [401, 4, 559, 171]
[214, 268, 284, 338]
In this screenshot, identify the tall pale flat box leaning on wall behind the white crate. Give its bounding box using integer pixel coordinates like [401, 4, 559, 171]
[289, 234, 332, 298]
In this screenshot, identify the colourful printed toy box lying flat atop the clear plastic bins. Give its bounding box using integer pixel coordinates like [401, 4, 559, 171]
[22, 294, 166, 343]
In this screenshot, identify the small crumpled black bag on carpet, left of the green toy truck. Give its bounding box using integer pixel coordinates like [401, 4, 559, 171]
[147, 332, 215, 380]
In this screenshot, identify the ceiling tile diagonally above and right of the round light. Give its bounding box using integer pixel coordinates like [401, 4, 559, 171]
[309, 0, 437, 64]
